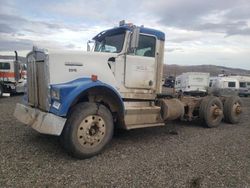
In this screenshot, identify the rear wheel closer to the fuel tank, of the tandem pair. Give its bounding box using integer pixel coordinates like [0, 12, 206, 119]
[200, 97, 223, 128]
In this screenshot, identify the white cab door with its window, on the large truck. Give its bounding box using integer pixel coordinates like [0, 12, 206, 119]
[125, 34, 156, 89]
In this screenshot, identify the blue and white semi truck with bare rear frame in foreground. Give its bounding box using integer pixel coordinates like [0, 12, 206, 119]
[14, 22, 242, 159]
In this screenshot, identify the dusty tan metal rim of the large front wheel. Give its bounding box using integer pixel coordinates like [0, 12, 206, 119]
[77, 115, 106, 147]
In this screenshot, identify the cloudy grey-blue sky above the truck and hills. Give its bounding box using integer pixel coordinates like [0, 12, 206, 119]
[0, 0, 250, 70]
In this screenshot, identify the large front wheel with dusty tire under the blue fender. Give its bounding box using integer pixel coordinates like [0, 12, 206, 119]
[61, 102, 114, 159]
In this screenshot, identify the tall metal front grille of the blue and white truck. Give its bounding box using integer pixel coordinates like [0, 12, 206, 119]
[27, 49, 49, 111]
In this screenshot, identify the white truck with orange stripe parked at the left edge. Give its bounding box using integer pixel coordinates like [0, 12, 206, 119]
[0, 53, 27, 97]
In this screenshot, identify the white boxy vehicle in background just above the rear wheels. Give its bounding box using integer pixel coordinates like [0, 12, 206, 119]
[175, 72, 210, 96]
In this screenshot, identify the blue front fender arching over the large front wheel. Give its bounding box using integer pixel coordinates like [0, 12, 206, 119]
[50, 78, 124, 117]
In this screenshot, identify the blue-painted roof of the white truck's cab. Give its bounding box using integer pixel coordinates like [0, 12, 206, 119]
[93, 25, 165, 41]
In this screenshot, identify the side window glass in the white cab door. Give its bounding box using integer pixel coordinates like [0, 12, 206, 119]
[135, 35, 156, 57]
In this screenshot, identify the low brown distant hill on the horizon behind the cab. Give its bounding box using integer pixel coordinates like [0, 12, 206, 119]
[163, 64, 250, 77]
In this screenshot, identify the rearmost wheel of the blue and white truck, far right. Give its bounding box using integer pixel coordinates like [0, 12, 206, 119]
[224, 96, 242, 124]
